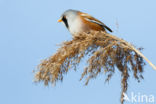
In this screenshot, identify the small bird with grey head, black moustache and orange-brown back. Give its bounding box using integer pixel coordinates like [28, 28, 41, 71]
[58, 9, 113, 35]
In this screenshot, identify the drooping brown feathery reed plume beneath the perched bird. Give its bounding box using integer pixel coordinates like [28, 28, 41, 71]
[35, 31, 145, 104]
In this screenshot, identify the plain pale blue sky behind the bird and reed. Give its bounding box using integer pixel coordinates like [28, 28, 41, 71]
[0, 0, 156, 104]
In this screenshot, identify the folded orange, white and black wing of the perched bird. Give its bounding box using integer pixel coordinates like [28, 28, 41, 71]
[81, 13, 113, 32]
